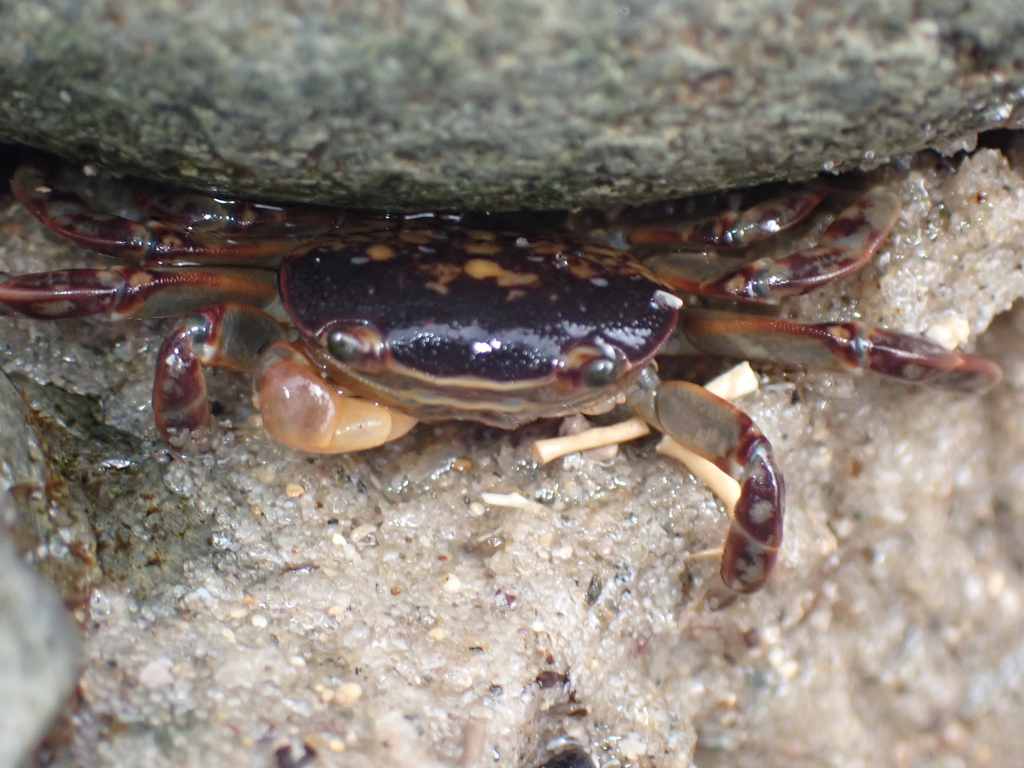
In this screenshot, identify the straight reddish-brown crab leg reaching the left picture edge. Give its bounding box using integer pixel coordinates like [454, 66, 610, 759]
[0, 266, 278, 319]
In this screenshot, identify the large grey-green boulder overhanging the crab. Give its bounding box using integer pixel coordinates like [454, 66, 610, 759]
[0, 0, 1024, 209]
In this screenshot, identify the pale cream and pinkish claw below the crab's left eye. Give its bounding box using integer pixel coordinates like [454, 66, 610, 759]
[254, 341, 418, 454]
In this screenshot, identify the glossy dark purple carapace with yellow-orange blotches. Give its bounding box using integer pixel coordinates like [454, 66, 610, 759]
[280, 222, 680, 386]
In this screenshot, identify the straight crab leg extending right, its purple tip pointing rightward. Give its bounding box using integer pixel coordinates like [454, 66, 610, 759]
[679, 310, 1002, 392]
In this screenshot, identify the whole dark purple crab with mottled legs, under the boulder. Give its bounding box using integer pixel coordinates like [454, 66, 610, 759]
[0, 160, 1000, 607]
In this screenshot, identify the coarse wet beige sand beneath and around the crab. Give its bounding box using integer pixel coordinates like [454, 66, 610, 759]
[0, 140, 1024, 768]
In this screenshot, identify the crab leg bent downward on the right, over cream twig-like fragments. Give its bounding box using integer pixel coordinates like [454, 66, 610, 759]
[627, 368, 785, 607]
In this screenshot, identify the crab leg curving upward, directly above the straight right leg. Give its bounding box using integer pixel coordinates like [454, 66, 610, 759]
[646, 188, 900, 303]
